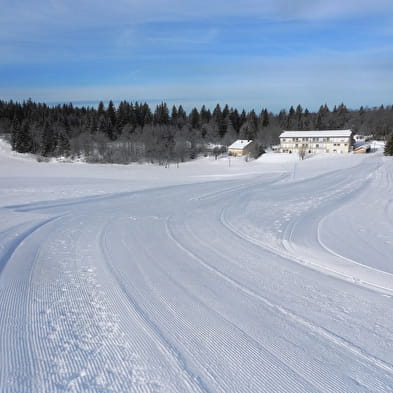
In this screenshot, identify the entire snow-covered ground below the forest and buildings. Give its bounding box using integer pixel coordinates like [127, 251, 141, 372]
[0, 142, 393, 393]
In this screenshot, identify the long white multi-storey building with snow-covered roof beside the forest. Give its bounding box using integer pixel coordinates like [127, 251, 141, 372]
[280, 130, 353, 153]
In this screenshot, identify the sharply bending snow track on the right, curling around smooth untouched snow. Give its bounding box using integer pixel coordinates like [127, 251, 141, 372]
[220, 156, 393, 295]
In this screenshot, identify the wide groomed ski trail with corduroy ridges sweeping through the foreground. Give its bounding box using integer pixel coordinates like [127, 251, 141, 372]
[0, 160, 393, 393]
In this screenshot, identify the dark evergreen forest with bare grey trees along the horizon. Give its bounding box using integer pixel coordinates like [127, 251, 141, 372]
[0, 99, 393, 164]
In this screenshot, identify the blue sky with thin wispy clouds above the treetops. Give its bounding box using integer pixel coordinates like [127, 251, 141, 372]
[0, 0, 393, 112]
